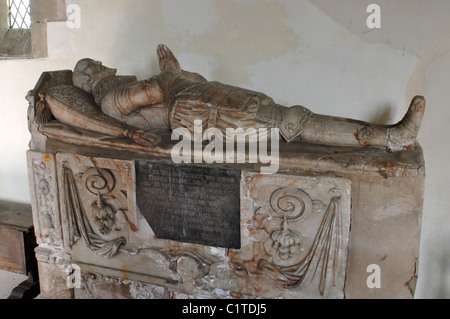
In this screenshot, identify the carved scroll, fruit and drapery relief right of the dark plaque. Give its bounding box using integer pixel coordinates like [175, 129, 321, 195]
[241, 188, 342, 295]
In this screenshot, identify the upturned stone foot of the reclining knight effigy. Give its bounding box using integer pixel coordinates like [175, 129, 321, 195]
[387, 96, 426, 151]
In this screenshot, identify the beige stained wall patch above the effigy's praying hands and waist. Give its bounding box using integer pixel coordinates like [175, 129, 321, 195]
[162, 1, 301, 84]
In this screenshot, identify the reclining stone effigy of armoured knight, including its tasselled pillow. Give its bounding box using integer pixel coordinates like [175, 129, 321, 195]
[36, 45, 425, 151]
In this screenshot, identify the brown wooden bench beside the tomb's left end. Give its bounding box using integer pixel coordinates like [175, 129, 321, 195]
[0, 201, 40, 299]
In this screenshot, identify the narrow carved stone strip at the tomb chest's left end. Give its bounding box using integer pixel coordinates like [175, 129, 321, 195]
[27, 151, 62, 246]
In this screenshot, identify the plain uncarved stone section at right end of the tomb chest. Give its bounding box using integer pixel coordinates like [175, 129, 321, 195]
[345, 174, 425, 298]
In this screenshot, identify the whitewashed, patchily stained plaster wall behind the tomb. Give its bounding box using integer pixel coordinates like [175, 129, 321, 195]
[0, 0, 450, 298]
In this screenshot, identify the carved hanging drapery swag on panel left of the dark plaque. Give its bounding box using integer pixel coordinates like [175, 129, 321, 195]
[63, 167, 126, 258]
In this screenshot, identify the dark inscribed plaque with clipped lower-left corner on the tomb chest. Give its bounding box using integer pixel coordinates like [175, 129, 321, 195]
[136, 162, 241, 249]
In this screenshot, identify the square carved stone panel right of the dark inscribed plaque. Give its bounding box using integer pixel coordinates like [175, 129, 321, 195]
[230, 173, 351, 298]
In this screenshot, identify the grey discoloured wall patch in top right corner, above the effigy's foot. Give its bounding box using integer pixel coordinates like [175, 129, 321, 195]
[308, 0, 450, 105]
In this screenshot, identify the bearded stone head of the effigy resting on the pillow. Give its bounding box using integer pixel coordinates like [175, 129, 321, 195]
[73, 59, 117, 93]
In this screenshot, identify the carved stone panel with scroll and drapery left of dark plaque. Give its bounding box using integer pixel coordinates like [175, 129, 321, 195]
[56, 154, 138, 258]
